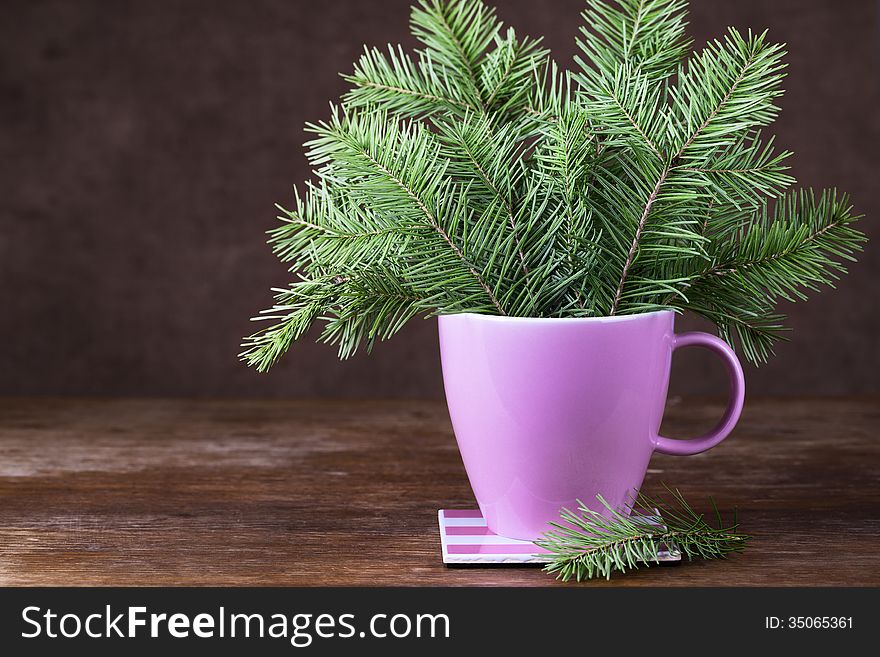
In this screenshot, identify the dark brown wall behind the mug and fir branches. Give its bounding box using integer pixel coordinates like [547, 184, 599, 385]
[0, 0, 880, 396]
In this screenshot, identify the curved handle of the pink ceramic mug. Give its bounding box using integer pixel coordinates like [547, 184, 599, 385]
[654, 331, 746, 456]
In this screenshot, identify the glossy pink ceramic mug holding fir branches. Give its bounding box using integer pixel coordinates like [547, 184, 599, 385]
[440, 311, 745, 540]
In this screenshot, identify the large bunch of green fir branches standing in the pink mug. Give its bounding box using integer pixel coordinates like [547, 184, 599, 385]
[241, 0, 865, 370]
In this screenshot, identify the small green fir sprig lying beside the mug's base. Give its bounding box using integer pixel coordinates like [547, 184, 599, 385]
[535, 488, 749, 582]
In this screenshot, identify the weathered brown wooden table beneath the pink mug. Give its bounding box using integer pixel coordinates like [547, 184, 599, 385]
[0, 398, 880, 586]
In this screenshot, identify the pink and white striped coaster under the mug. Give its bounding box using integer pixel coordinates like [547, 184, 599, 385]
[437, 509, 681, 564]
